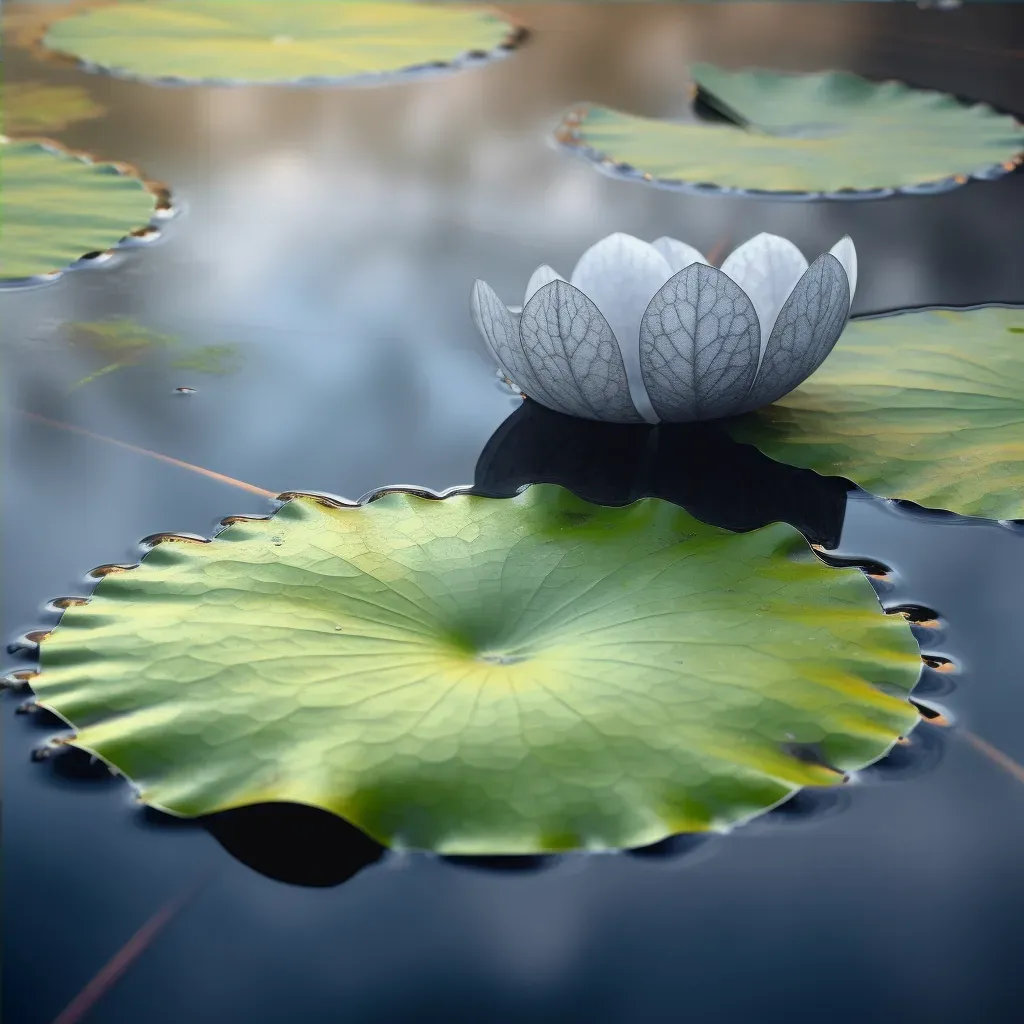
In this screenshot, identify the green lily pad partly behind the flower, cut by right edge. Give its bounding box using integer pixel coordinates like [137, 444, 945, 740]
[728, 306, 1024, 519]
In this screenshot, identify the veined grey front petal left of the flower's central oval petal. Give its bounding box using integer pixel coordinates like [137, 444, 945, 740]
[519, 279, 642, 423]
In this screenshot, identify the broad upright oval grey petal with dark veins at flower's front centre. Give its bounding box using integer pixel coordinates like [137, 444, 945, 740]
[640, 263, 761, 423]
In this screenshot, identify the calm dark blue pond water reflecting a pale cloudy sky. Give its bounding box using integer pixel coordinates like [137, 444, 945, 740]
[0, 4, 1024, 1024]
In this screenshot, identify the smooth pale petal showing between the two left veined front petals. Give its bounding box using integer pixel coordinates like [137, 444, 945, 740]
[571, 233, 672, 423]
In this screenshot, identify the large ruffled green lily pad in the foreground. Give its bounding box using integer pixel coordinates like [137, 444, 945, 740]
[33, 484, 921, 854]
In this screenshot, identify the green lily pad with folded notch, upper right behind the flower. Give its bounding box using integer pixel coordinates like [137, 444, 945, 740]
[559, 63, 1024, 195]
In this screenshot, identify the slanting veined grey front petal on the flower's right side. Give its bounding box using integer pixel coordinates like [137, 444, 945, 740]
[743, 253, 850, 411]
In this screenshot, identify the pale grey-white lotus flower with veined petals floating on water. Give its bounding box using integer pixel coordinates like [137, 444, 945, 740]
[471, 234, 857, 423]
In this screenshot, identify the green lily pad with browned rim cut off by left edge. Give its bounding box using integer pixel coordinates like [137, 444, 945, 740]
[0, 139, 164, 286]
